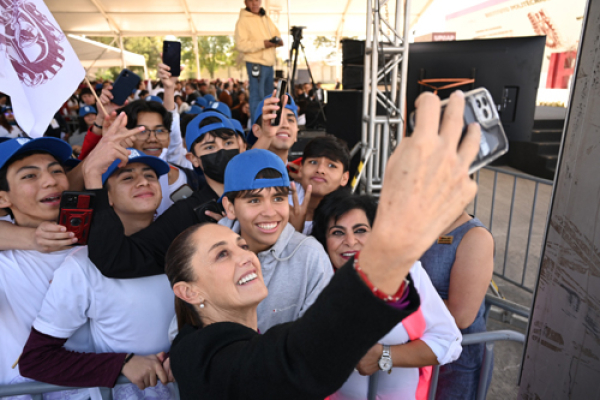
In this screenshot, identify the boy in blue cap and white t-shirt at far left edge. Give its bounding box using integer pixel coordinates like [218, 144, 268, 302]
[0, 138, 88, 384]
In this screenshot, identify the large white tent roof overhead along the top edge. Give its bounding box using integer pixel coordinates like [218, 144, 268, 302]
[45, 0, 433, 78]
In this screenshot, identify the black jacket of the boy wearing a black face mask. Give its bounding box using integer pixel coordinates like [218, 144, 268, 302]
[88, 185, 219, 279]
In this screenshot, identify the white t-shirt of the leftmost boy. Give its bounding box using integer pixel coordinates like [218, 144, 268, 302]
[0, 249, 87, 390]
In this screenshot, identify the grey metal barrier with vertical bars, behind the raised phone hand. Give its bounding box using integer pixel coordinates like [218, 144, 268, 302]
[467, 167, 553, 293]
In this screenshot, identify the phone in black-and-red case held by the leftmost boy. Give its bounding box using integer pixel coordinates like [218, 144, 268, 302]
[58, 191, 96, 246]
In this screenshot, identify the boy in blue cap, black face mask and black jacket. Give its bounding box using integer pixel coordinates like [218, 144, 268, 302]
[77, 111, 245, 278]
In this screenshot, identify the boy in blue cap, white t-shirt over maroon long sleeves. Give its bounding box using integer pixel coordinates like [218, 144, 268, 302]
[19, 149, 174, 394]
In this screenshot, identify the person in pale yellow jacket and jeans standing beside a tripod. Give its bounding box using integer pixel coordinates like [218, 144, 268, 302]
[235, 0, 283, 124]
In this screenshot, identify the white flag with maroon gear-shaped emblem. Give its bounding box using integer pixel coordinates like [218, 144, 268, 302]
[0, 0, 85, 137]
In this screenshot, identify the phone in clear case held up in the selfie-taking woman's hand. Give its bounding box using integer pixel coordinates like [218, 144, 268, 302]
[409, 88, 508, 174]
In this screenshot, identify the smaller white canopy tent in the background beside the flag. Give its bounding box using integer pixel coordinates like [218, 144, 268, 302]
[67, 34, 147, 75]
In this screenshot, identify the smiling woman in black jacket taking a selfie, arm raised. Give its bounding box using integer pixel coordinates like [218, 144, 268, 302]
[166, 92, 479, 400]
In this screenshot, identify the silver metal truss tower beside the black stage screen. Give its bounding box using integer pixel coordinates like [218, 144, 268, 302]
[353, 0, 410, 194]
